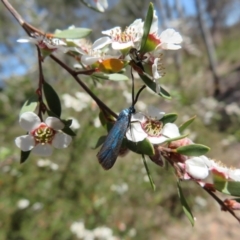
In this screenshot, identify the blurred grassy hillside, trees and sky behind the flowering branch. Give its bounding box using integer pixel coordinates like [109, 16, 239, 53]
[0, 0, 240, 240]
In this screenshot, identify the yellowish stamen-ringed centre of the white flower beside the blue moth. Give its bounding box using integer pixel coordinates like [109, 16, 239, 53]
[142, 119, 163, 137]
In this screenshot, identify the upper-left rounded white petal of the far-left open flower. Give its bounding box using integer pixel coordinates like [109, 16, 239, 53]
[19, 112, 41, 132]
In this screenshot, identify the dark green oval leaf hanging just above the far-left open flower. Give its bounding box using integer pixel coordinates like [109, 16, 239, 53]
[43, 82, 62, 117]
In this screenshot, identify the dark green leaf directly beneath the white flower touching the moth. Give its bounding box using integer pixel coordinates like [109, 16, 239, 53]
[123, 138, 155, 156]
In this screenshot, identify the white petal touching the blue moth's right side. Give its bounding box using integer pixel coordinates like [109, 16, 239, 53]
[126, 123, 147, 142]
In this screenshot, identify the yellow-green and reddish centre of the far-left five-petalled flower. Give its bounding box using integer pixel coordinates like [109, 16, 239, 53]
[32, 124, 56, 145]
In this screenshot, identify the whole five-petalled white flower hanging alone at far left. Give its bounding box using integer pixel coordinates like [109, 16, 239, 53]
[15, 112, 72, 156]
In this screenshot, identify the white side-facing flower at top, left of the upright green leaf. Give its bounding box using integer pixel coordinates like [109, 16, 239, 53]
[93, 19, 143, 50]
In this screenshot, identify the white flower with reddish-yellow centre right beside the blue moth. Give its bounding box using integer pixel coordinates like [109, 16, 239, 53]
[126, 107, 180, 144]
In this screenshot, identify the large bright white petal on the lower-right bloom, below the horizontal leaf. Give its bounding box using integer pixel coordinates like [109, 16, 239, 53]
[185, 157, 209, 179]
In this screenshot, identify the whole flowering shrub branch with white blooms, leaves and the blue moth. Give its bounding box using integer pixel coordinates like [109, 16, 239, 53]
[2, 0, 240, 224]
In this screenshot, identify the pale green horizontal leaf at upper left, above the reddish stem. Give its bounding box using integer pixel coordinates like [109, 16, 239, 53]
[54, 28, 92, 39]
